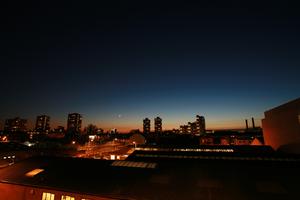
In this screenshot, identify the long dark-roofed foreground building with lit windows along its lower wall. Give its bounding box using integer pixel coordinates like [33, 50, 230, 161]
[0, 152, 300, 200]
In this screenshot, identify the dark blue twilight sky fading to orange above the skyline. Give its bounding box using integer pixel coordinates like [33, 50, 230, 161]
[0, 0, 300, 132]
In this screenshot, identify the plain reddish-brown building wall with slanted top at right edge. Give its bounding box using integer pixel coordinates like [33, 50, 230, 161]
[262, 98, 300, 150]
